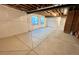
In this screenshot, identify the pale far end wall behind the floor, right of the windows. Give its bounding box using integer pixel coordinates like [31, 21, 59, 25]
[47, 17, 66, 30]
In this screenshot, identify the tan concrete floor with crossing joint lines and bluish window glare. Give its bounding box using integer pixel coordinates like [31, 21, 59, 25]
[0, 27, 79, 55]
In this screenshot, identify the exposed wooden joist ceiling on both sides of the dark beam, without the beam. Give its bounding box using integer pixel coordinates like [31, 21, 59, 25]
[6, 4, 67, 16]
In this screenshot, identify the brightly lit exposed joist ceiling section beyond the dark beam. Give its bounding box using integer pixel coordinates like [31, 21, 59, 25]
[36, 8, 67, 16]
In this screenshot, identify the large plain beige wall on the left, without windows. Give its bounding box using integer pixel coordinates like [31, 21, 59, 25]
[0, 5, 28, 38]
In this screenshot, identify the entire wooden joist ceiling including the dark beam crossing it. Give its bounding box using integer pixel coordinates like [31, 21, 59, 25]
[5, 4, 79, 16]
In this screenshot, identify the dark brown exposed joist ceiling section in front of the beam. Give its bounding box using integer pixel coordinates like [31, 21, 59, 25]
[6, 4, 53, 12]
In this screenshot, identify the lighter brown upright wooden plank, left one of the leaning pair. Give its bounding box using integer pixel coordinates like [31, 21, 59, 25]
[64, 10, 75, 33]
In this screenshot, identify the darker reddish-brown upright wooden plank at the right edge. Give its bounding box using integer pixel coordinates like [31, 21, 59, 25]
[72, 10, 79, 37]
